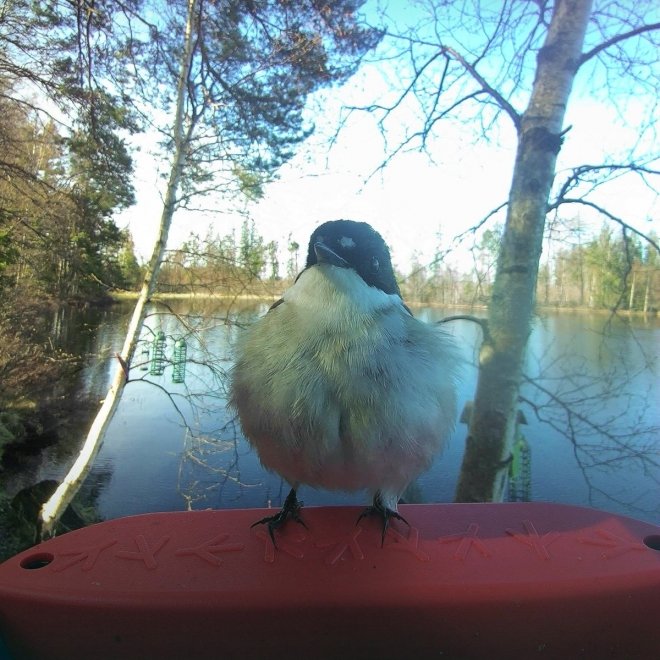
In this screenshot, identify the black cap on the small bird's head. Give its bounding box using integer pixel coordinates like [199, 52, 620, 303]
[306, 220, 401, 295]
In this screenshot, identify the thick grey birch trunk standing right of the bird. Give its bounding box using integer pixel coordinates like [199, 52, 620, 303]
[456, 0, 592, 502]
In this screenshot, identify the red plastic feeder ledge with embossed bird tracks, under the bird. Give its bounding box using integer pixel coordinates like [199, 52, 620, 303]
[0, 503, 660, 659]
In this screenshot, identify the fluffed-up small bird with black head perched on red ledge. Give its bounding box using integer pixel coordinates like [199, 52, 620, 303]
[229, 220, 459, 543]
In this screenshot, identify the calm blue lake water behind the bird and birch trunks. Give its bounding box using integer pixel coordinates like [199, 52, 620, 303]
[6, 301, 660, 523]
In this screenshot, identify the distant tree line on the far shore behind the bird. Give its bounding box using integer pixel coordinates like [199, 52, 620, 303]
[159, 215, 660, 313]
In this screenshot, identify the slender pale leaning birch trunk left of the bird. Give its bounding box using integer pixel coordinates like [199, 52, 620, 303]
[39, 0, 198, 538]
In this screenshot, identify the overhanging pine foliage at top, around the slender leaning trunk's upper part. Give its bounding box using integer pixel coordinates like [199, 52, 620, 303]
[132, 0, 381, 197]
